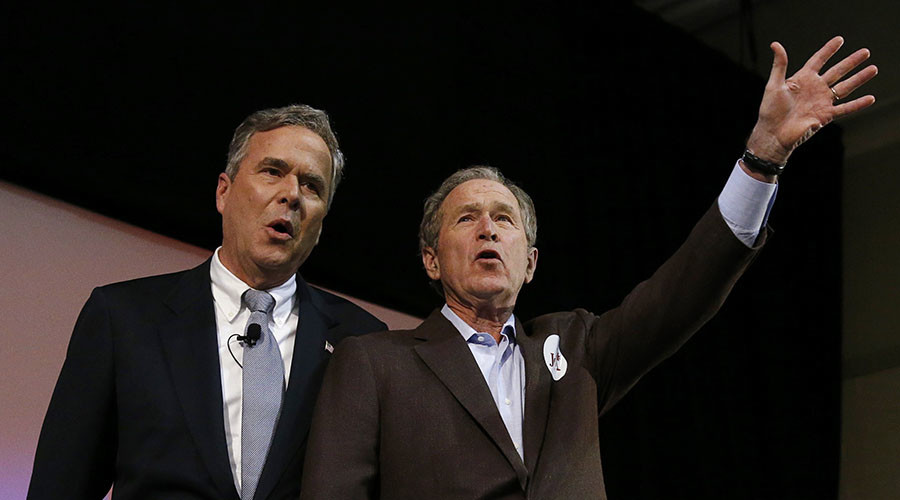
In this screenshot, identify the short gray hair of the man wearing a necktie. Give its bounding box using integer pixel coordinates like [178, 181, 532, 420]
[225, 104, 344, 208]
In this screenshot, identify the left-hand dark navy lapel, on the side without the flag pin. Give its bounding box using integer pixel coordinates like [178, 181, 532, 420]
[159, 260, 238, 500]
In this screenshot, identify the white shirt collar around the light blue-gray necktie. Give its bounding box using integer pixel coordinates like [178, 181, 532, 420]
[209, 247, 297, 326]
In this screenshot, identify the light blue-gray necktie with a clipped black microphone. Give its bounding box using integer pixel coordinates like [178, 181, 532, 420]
[241, 288, 284, 500]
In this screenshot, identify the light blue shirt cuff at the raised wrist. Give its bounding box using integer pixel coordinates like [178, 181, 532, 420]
[719, 159, 778, 247]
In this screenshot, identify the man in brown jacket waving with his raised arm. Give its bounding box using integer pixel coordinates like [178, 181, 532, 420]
[302, 37, 877, 499]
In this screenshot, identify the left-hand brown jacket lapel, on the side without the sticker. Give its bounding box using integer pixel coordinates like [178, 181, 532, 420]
[415, 310, 528, 489]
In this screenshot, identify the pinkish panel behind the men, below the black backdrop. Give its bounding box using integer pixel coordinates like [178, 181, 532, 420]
[0, 182, 421, 499]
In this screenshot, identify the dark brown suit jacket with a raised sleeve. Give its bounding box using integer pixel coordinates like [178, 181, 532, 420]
[301, 201, 765, 500]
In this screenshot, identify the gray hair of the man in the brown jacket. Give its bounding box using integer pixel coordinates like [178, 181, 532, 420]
[419, 165, 537, 253]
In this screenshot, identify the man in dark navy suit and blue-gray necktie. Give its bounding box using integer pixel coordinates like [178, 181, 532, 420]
[28, 105, 385, 500]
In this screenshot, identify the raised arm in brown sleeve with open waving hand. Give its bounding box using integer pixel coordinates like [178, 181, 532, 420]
[585, 37, 878, 411]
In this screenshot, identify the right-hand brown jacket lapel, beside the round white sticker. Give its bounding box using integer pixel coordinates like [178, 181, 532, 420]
[516, 320, 553, 475]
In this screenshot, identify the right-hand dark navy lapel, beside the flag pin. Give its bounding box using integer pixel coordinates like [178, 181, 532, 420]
[255, 274, 345, 499]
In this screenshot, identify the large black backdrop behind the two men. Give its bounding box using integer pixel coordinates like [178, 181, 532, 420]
[0, 2, 842, 499]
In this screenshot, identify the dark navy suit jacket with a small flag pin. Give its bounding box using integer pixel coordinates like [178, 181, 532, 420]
[28, 260, 385, 500]
